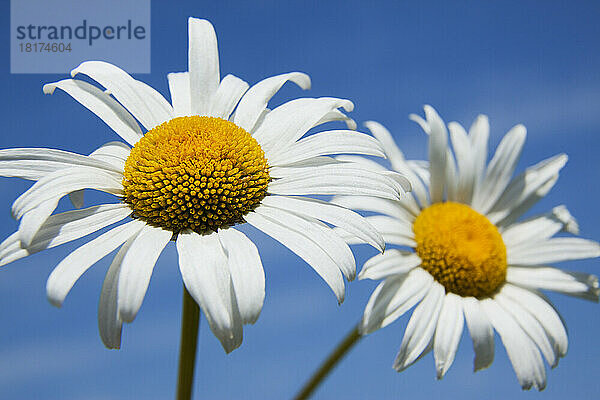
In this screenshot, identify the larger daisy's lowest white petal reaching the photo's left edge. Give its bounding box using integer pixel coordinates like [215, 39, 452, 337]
[0, 204, 131, 265]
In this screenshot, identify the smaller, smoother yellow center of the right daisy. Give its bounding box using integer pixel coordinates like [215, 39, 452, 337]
[413, 202, 506, 298]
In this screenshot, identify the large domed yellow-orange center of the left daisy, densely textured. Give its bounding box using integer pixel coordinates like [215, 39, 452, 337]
[123, 116, 269, 233]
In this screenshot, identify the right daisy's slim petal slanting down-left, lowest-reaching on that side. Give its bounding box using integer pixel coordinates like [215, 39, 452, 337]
[394, 282, 444, 372]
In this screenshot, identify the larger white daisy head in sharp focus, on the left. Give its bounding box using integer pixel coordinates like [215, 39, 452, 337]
[0, 18, 408, 352]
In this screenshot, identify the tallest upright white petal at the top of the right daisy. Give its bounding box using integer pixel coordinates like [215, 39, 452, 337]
[424, 106, 448, 203]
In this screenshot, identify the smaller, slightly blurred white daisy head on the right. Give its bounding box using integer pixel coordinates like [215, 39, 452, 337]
[334, 106, 600, 390]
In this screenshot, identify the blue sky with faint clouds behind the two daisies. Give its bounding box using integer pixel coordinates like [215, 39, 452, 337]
[0, 0, 600, 400]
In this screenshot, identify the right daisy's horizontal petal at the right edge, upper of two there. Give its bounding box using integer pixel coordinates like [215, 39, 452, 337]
[507, 237, 600, 265]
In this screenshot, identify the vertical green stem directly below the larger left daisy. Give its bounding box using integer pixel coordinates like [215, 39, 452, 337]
[177, 286, 200, 400]
